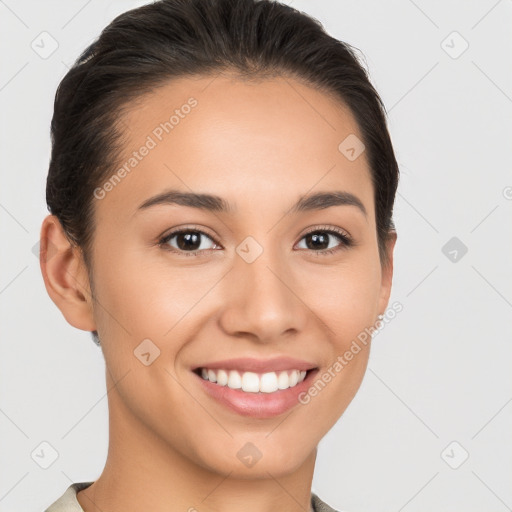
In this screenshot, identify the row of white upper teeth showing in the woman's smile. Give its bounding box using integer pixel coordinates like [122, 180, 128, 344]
[201, 368, 306, 393]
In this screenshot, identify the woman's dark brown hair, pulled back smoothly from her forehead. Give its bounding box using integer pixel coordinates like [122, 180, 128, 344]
[46, 0, 399, 344]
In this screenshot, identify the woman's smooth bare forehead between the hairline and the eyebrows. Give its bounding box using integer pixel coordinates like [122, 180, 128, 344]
[106, 75, 373, 218]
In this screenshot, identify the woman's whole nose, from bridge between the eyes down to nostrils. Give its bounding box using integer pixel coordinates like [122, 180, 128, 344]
[222, 240, 304, 341]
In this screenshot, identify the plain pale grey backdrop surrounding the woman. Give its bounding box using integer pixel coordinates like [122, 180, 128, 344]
[0, 0, 512, 512]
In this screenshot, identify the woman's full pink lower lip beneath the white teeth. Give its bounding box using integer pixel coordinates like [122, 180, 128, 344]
[192, 369, 318, 418]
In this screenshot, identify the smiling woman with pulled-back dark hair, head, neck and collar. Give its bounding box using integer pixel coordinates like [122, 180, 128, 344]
[41, 0, 398, 512]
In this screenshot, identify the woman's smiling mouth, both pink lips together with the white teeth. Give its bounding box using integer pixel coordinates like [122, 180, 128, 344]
[192, 358, 319, 419]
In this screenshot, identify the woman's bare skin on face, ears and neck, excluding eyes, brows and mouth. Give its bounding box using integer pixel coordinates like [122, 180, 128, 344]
[41, 75, 396, 512]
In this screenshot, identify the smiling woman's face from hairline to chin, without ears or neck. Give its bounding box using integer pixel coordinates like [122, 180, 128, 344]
[84, 76, 392, 478]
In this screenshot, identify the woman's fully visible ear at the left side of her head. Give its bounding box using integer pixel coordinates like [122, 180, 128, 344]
[39, 215, 96, 331]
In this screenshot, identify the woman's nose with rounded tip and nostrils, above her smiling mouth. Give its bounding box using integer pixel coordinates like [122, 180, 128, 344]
[220, 251, 311, 343]
